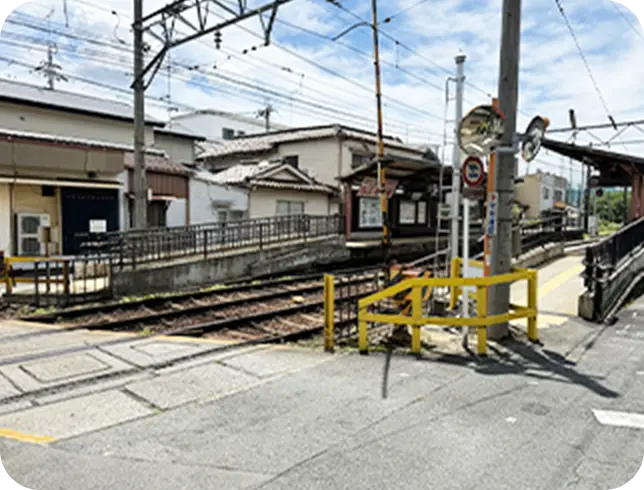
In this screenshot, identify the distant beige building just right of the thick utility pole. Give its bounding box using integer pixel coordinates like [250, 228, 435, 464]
[515, 171, 567, 219]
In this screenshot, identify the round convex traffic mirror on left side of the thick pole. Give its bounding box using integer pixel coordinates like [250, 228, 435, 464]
[457, 105, 505, 158]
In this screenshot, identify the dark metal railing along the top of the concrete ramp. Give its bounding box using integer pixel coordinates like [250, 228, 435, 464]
[77, 215, 344, 269]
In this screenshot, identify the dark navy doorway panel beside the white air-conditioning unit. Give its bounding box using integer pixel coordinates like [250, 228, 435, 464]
[60, 187, 119, 255]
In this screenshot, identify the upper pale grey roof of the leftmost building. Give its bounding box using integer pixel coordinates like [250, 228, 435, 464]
[0, 79, 163, 125]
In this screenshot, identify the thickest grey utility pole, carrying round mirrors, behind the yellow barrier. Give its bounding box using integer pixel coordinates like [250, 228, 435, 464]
[488, 0, 521, 340]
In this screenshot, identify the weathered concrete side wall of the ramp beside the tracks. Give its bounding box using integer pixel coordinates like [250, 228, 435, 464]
[112, 237, 349, 297]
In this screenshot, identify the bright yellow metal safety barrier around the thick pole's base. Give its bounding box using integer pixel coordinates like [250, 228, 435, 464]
[358, 259, 538, 355]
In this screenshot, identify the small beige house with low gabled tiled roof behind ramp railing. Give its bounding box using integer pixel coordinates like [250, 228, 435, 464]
[212, 161, 340, 219]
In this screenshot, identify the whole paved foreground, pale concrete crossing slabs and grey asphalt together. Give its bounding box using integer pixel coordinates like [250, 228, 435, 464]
[0, 296, 644, 490]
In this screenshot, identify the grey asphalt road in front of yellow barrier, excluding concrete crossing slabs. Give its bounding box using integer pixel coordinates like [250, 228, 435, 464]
[0, 302, 644, 490]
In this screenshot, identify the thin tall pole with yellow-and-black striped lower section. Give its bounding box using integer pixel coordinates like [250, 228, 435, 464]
[371, 0, 391, 256]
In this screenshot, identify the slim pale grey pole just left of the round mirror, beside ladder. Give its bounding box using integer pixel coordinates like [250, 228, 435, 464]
[450, 54, 465, 259]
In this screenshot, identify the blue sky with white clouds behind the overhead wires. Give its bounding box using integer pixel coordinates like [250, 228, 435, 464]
[0, 0, 644, 185]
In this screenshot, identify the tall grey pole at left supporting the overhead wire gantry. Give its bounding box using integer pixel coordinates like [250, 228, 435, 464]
[133, 0, 148, 229]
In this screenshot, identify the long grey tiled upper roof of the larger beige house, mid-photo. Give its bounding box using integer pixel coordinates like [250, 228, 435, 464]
[198, 125, 423, 160]
